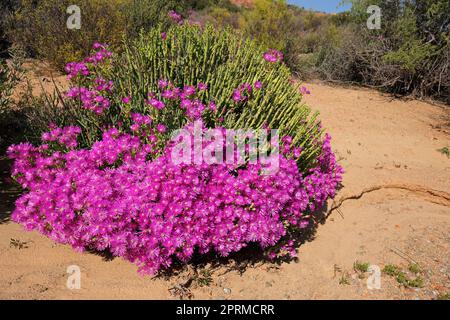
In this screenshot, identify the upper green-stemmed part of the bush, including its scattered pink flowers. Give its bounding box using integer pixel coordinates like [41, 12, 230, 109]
[60, 23, 323, 170]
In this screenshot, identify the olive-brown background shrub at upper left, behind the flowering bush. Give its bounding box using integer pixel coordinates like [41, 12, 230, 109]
[8, 0, 126, 68]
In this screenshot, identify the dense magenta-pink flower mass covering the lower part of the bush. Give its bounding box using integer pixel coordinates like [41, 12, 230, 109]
[8, 122, 342, 274]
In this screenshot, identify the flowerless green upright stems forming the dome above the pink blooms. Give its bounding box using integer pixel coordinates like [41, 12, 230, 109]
[102, 25, 321, 166]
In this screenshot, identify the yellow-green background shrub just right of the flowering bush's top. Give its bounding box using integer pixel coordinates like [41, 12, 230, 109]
[195, 0, 332, 77]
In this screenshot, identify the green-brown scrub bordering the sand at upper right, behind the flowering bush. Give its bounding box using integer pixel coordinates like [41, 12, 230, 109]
[193, 0, 450, 103]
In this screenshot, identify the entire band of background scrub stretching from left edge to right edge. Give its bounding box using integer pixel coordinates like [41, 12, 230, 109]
[0, 0, 450, 103]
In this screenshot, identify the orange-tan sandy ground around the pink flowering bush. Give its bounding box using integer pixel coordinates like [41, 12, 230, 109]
[0, 72, 450, 299]
